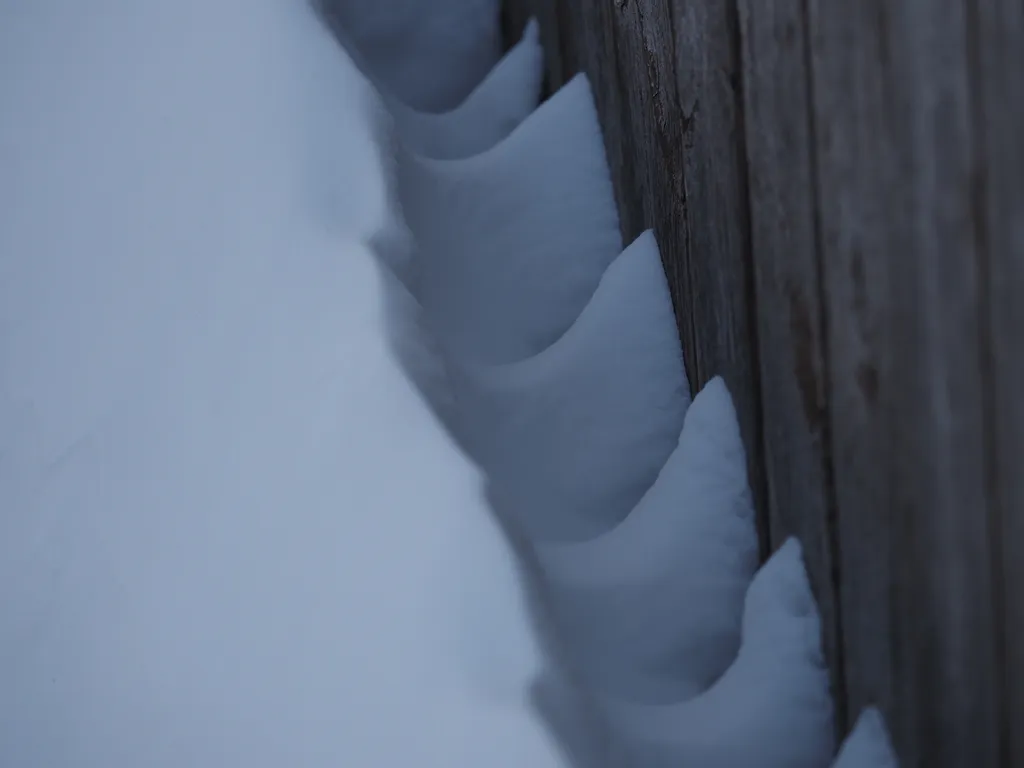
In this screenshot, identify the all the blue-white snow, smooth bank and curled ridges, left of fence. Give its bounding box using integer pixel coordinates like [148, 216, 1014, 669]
[0, 0, 896, 768]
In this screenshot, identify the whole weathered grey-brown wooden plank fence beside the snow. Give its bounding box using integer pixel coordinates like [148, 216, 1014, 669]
[507, 0, 1024, 768]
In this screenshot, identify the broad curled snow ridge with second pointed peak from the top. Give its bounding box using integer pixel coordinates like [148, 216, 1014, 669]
[396, 75, 622, 362]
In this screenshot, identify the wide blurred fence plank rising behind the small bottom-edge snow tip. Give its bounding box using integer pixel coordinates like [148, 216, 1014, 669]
[809, 0, 999, 768]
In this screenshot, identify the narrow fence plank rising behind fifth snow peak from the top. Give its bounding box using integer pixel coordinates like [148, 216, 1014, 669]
[738, 0, 843, 735]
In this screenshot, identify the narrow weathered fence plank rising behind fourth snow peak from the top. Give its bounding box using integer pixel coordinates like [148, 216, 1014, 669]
[667, 0, 770, 542]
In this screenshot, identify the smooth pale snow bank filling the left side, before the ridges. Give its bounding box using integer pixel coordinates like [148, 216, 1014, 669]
[0, 0, 563, 768]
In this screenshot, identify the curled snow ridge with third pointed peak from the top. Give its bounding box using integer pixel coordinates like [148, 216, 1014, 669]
[451, 231, 689, 542]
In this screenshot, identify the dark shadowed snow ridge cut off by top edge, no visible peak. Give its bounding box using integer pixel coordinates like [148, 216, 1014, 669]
[314, 0, 502, 112]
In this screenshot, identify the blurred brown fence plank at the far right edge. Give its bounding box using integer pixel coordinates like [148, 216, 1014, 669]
[966, 0, 1024, 766]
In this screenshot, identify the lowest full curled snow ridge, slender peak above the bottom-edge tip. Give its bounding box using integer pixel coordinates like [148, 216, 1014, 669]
[605, 540, 833, 768]
